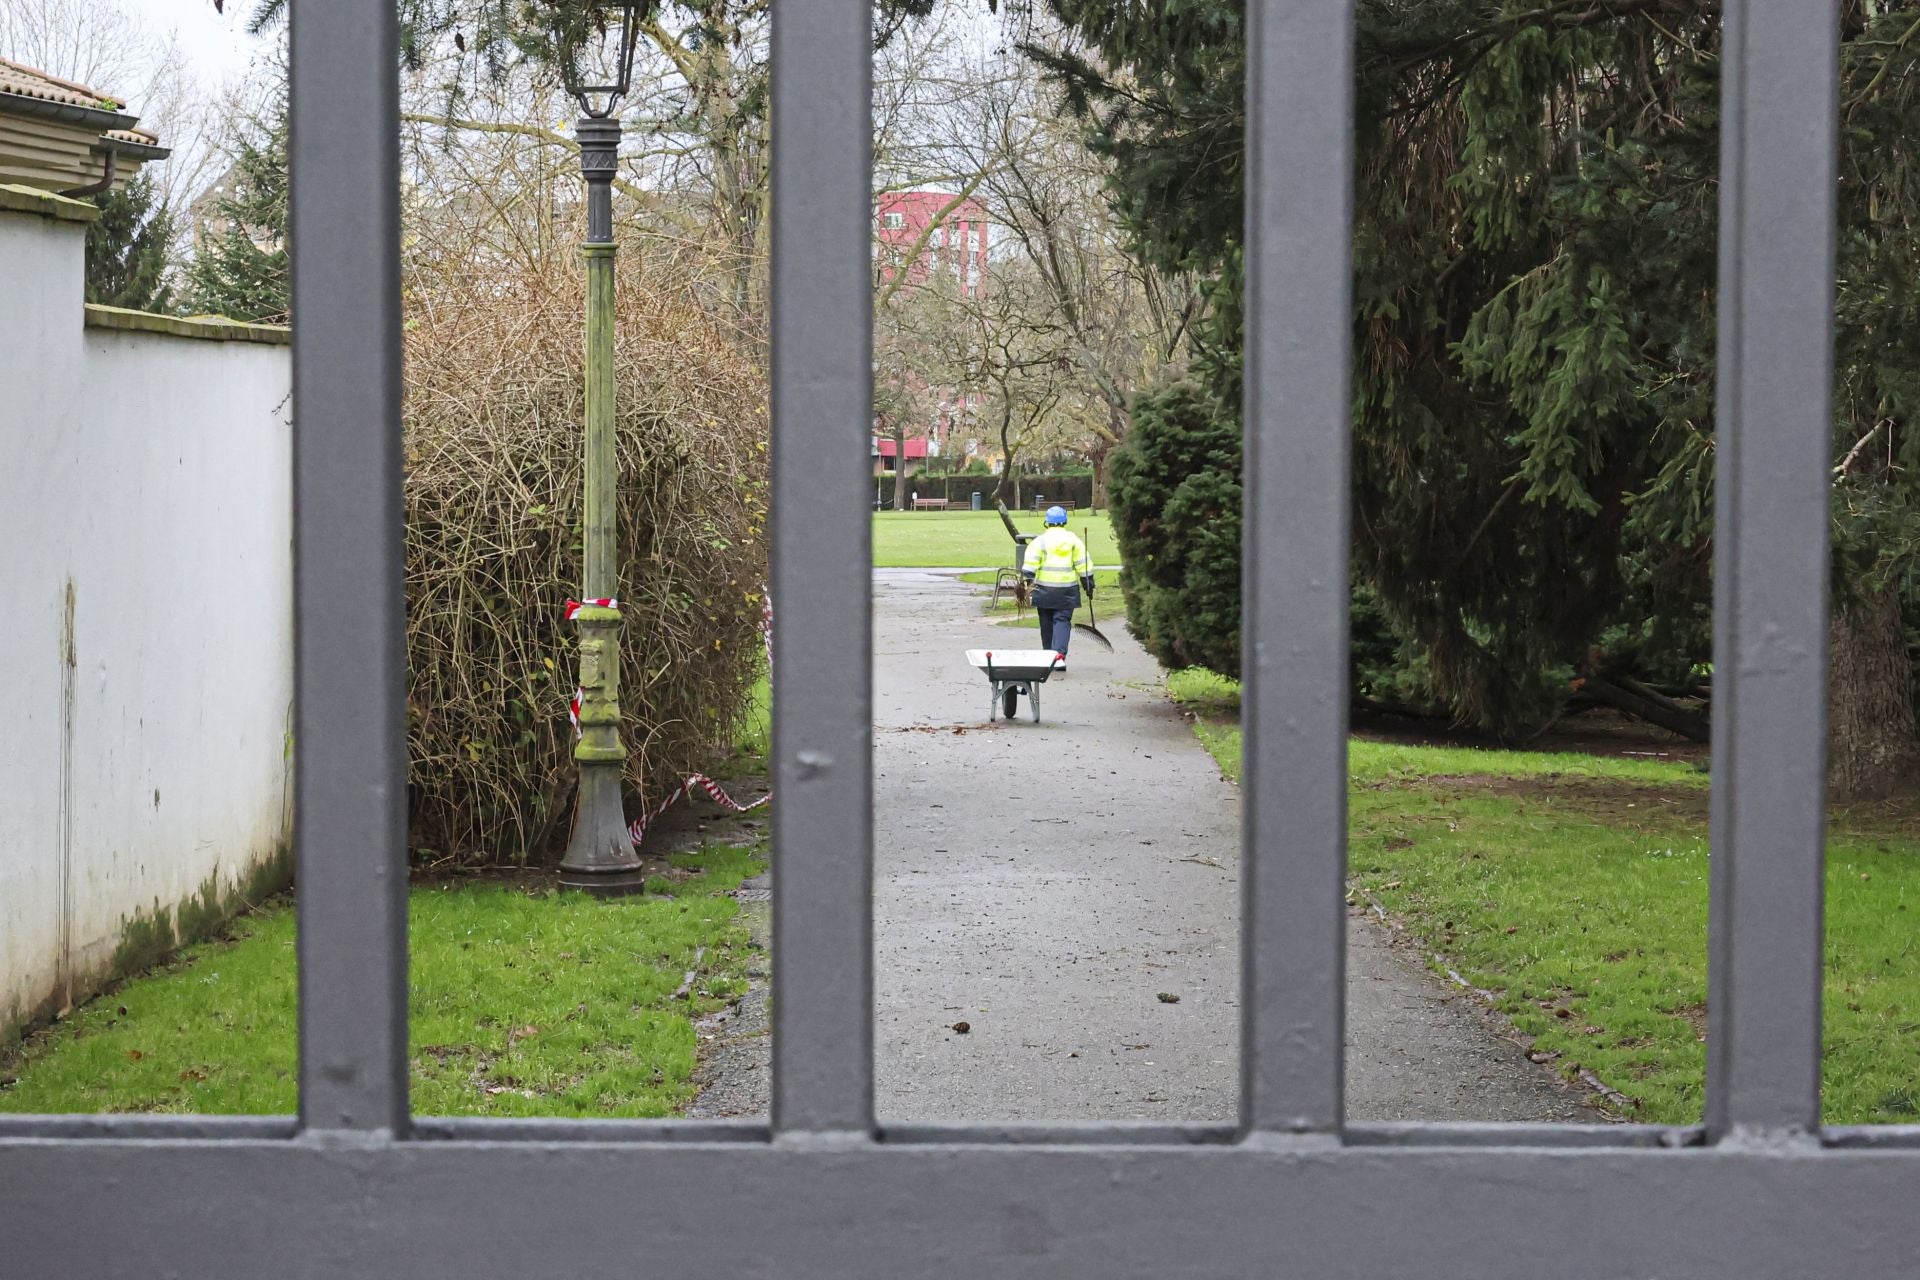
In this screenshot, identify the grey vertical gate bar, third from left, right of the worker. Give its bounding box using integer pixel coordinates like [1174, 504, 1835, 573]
[1240, 0, 1354, 1132]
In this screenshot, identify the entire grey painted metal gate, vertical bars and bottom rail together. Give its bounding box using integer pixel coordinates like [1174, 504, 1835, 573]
[0, 0, 1920, 1280]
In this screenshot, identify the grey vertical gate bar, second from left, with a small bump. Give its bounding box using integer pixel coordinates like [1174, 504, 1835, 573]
[772, 0, 874, 1132]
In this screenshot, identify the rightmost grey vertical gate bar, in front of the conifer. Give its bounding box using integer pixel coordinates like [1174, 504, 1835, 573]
[1707, 0, 1839, 1136]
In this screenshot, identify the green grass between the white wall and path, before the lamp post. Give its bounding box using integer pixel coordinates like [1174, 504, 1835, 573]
[0, 846, 764, 1117]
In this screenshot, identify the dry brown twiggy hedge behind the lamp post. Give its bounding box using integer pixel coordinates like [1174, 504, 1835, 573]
[405, 253, 766, 865]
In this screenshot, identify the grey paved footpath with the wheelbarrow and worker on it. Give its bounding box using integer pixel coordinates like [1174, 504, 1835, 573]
[874, 570, 1597, 1121]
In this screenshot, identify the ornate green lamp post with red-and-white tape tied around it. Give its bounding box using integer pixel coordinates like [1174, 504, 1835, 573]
[557, 2, 643, 896]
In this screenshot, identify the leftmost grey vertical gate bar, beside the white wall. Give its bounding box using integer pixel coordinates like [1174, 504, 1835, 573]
[290, 0, 407, 1132]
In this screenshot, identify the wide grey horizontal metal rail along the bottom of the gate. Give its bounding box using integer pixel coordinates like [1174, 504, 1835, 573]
[0, 1142, 1916, 1280]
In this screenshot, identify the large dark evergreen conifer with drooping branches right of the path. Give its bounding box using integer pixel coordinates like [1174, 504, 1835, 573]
[1031, 0, 1920, 794]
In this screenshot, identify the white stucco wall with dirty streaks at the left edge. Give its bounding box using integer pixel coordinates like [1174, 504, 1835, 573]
[0, 192, 292, 1034]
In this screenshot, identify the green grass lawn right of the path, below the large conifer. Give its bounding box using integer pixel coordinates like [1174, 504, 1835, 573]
[1167, 672, 1920, 1125]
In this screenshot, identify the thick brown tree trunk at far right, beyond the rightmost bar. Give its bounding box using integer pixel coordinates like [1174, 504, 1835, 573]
[1826, 587, 1920, 800]
